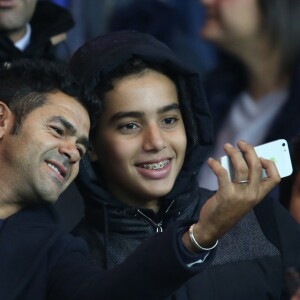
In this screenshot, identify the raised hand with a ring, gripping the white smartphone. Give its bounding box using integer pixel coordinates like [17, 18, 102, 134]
[197, 141, 280, 244]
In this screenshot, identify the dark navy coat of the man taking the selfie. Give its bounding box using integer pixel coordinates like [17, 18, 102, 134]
[0, 205, 209, 300]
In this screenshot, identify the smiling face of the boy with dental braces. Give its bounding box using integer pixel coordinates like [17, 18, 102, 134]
[93, 70, 187, 210]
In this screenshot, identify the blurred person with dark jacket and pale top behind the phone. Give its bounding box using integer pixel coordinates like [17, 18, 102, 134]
[199, 0, 300, 189]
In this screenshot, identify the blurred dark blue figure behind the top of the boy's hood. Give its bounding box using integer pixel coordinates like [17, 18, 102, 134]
[56, 0, 218, 74]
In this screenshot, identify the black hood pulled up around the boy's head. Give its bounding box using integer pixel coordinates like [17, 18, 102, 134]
[70, 30, 213, 206]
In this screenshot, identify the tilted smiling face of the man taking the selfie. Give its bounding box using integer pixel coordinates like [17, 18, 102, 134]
[0, 92, 90, 203]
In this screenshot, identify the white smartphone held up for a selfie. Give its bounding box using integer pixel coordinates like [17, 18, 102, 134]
[220, 139, 293, 180]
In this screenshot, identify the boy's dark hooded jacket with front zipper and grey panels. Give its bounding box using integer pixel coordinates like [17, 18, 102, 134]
[70, 31, 300, 300]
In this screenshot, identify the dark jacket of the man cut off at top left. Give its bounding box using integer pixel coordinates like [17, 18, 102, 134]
[0, 1, 74, 62]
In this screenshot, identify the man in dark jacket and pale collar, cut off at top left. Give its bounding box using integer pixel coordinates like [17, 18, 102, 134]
[0, 0, 74, 61]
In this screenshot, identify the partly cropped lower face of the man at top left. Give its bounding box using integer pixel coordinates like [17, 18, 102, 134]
[0, 0, 37, 42]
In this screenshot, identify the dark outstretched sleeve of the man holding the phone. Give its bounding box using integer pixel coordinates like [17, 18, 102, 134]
[47, 224, 213, 300]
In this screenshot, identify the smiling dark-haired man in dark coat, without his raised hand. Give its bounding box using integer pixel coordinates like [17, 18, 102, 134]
[0, 60, 218, 300]
